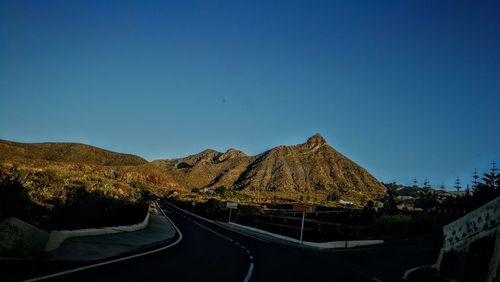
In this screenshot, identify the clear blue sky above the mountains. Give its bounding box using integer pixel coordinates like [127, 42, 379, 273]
[0, 0, 500, 187]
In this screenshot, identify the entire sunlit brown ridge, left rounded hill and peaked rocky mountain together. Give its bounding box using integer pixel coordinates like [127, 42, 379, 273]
[0, 134, 385, 203]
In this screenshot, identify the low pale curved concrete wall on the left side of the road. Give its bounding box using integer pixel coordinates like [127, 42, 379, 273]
[45, 213, 149, 252]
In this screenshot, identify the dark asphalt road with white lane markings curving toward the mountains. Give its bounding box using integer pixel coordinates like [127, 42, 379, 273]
[3, 200, 438, 282]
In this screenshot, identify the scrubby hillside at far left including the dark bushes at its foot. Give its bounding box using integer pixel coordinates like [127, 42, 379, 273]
[0, 141, 178, 228]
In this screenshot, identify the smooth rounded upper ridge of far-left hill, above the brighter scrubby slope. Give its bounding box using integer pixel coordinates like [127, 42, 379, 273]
[0, 140, 148, 166]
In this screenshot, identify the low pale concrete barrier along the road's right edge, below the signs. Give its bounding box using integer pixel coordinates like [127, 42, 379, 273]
[229, 222, 384, 249]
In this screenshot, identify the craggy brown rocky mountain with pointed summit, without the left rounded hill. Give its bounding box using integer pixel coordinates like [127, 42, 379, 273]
[153, 134, 386, 201]
